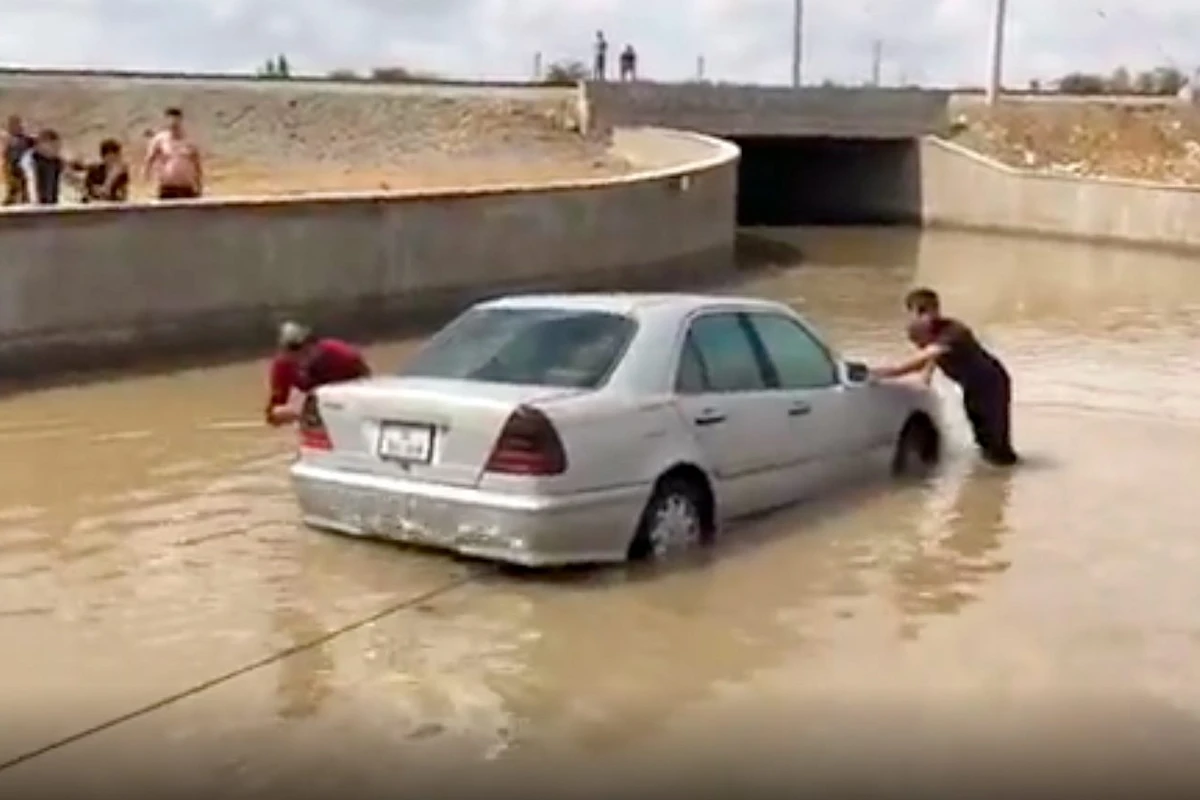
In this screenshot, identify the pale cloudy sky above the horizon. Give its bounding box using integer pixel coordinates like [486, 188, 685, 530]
[0, 0, 1200, 86]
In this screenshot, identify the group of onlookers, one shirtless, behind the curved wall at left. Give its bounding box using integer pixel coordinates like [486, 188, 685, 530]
[0, 108, 204, 206]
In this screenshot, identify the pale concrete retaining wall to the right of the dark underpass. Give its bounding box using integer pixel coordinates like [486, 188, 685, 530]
[920, 138, 1200, 249]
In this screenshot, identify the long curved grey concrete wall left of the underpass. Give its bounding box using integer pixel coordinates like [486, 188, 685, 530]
[0, 131, 738, 375]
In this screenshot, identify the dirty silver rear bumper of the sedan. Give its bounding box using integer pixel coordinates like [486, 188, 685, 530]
[290, 461, 650, 567]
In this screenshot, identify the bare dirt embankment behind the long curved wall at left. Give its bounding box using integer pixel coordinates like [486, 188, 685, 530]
[0, 78, 629, 197]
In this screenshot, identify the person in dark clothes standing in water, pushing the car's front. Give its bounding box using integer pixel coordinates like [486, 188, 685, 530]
[871, 289, 1019, 467]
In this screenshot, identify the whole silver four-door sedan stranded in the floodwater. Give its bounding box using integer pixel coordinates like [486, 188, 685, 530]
[292, 294, 941, 566]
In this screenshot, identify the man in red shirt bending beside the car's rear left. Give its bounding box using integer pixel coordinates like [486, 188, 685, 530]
[266, 323, 371, 426]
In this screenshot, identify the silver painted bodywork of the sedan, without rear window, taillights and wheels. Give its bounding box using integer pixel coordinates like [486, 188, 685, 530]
[292, 294, 938, 566]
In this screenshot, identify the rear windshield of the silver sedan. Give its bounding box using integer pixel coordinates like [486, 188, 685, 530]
[400, 308, 637, 389]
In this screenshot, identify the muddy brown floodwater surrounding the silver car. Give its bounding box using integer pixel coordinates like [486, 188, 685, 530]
[0, 230, 1200, 798]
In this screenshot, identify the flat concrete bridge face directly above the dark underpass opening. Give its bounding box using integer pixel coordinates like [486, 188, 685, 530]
[584, 82, 949, 139]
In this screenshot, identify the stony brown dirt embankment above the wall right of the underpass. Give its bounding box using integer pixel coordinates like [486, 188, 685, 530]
[953, 101, 1200, 185]
